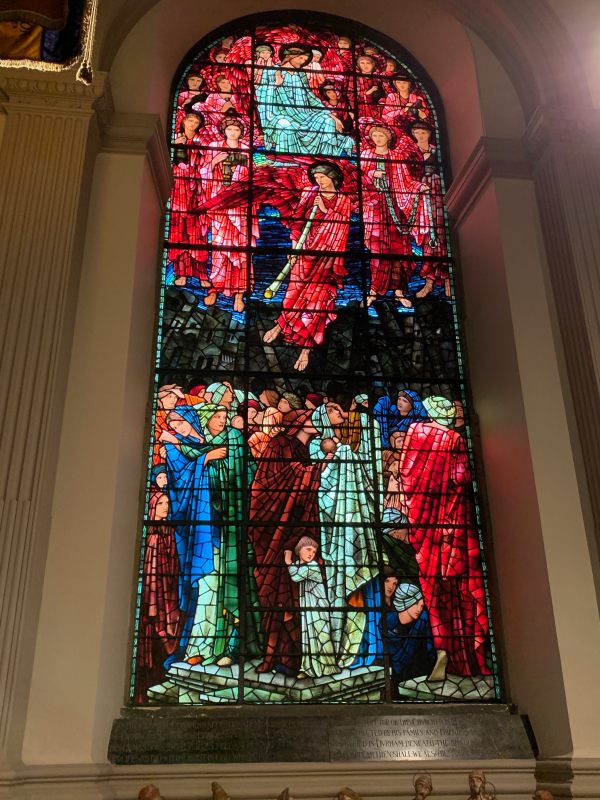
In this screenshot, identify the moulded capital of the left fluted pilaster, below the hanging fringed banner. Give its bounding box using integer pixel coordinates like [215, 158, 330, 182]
[0, 69, 107, 116]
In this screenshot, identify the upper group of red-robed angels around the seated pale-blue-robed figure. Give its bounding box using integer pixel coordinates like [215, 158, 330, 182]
[167, 25, 450, 370]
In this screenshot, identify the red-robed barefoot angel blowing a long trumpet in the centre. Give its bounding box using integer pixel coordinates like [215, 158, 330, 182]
[263, 161, 352, 371]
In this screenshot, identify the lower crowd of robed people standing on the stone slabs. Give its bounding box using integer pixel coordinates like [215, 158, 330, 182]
[136, 381, 490, 702]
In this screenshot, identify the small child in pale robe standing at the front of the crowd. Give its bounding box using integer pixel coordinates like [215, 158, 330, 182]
[284, 536, 339, 678]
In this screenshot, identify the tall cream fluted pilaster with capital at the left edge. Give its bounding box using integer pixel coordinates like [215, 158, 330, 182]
[0, 72, 103, 758]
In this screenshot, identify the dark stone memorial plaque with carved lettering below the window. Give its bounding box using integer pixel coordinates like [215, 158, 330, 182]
[109, 706, 532, 764]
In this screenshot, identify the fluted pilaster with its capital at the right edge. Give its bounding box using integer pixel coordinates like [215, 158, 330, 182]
[525, 108, 600, 558]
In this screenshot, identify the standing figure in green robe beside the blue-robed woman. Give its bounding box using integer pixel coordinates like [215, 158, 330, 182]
[186, 403, 261, 666]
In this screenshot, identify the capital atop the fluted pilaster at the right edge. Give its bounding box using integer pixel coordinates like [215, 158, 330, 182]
[523, 106, 600, 160]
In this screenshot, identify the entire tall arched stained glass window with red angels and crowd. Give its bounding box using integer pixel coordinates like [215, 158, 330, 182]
[131, 14, 498, 704]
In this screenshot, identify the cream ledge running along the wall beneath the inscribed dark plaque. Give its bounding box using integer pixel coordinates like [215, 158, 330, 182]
[0, 759, 540, 800]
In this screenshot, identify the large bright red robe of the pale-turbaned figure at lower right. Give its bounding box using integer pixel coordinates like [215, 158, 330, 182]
[399, 422, 490, 675]
